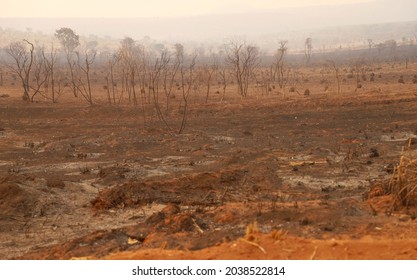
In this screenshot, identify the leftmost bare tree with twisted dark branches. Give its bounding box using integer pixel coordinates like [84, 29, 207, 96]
[6, 40, 35, 101]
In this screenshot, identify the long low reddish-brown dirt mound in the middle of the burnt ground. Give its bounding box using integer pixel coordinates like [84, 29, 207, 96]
[91, 170, 245, 210]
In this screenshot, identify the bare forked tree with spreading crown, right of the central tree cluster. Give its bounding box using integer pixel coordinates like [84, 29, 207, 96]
[226, 42, 259, 97]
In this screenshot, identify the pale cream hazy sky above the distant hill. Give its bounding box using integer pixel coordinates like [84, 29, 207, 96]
[0, 0, 373, 17]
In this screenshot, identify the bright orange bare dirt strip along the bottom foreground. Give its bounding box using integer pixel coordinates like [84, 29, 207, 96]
[105, 235, 417, 260]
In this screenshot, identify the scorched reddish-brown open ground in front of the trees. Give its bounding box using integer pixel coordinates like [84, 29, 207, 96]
[0, 65, 417, 259]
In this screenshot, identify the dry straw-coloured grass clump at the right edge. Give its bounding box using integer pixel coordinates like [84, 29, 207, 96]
[389, 138, 417, 210]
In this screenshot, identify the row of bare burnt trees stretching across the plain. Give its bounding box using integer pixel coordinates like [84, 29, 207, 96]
[1, 27, 415, 132]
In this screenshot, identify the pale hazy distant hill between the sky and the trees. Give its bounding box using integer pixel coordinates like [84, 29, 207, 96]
[0, 0, 417, 50]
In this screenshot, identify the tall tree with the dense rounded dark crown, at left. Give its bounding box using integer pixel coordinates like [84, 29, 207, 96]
[55, 27, 80, 97]
